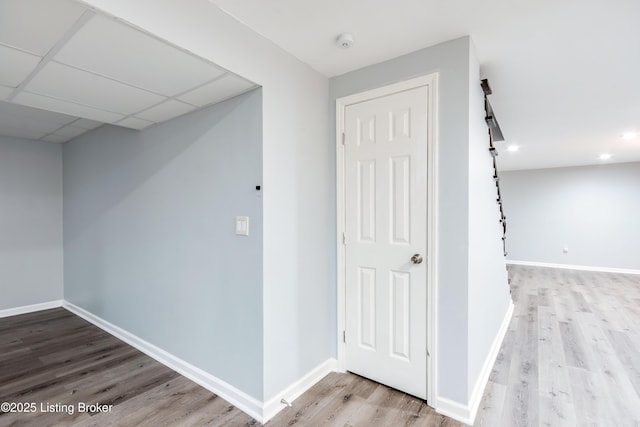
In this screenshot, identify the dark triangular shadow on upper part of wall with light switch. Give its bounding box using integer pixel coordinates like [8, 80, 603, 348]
[63, 88, 262, 241]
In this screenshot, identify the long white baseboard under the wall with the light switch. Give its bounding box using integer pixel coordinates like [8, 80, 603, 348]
[62, 301, 266, 423]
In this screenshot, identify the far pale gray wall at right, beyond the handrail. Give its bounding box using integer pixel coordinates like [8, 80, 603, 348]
[501, 162, 640, 270]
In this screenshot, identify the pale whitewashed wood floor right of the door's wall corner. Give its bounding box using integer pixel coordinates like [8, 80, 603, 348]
[476, 266, 640, 427]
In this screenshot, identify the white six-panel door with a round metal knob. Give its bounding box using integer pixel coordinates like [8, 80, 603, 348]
[344, 86, 429, 399]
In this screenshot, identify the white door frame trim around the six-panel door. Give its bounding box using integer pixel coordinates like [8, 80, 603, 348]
[336, 73, 438, 406]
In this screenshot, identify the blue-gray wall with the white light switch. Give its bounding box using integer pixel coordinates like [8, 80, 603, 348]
[63, 90, 263, 400]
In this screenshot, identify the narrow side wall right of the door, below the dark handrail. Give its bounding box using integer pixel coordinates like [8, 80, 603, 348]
[468, 43, 511, 397]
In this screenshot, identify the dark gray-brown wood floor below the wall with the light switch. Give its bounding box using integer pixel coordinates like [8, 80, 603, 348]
[0, 309, 255, 427]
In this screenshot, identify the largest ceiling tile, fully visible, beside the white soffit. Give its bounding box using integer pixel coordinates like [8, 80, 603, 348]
[54, 15, 224, 96]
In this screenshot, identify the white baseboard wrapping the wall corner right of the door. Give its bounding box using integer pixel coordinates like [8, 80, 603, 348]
[435, 301, 514, 425]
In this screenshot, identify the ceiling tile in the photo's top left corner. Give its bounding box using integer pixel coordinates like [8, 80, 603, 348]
[0, 0, 86, 56]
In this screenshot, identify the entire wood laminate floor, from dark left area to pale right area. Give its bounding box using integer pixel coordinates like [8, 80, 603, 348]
[0, 266, 640, 427]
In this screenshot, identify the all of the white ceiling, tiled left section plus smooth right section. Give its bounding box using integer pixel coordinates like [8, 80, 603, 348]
[0, 0, 640, 169]
